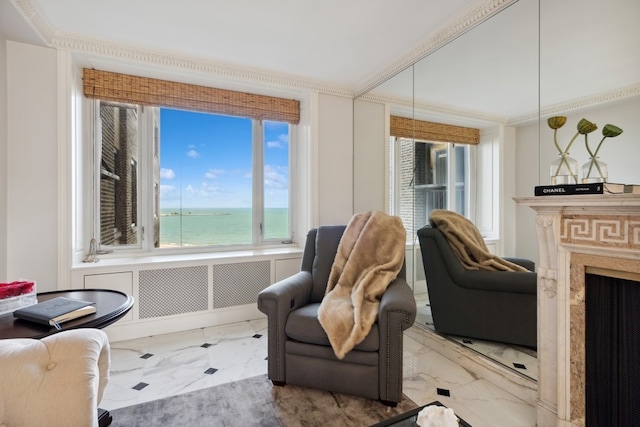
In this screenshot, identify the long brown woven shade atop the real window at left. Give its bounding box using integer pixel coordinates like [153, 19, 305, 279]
[83, 68, 300, 124]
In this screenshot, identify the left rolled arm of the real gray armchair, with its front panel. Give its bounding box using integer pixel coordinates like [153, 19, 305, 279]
[258, 271, 313, 383]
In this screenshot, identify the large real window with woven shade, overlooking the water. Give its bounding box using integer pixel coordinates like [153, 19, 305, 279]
[78, 68, 300, 251]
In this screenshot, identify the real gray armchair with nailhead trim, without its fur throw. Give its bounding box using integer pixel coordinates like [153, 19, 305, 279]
[258, 225, 416, 406]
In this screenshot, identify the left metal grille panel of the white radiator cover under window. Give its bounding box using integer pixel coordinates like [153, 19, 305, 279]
[139, 265, 209, 319]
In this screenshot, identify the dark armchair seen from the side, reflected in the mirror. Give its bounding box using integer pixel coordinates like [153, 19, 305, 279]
[418, 226, 537, 348]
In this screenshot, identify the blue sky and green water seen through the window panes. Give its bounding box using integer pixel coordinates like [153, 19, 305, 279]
[155, 108, 290, 247]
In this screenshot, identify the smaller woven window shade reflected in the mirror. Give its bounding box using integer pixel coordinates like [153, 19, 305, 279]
[390, 116, 480, 144]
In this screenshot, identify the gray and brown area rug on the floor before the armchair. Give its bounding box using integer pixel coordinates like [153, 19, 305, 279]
[110, 375, 418, 427]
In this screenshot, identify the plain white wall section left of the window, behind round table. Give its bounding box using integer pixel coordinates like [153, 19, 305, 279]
[6, 42, 58, 291]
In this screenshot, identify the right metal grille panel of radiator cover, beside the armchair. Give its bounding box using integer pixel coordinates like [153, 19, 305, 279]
[213, 261, 271, 308]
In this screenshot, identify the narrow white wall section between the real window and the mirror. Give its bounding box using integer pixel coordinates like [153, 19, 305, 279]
[314, 94, 353, 225]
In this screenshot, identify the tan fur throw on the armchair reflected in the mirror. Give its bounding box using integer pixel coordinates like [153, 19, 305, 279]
[429, 209, 529, 271]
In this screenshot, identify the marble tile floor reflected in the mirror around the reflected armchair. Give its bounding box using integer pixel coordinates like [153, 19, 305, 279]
[415, 294, 538, 380]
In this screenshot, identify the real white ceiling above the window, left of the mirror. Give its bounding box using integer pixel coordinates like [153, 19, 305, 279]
[0, 0, 478, 88]
